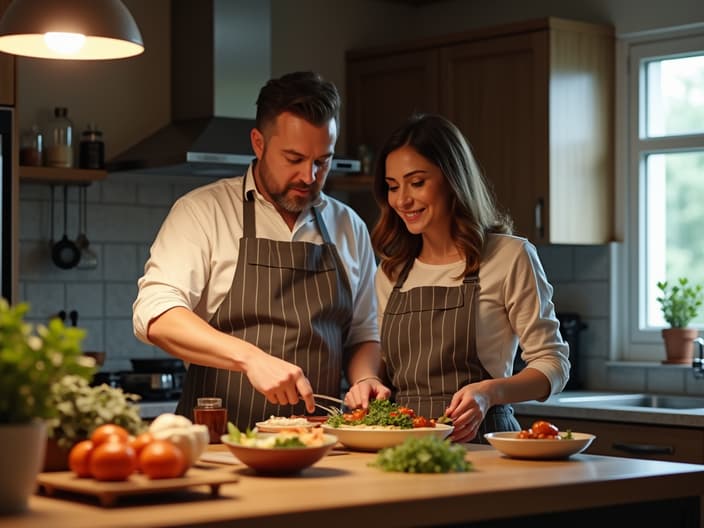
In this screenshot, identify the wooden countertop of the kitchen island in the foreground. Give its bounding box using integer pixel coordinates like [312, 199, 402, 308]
[0, 446, 704, 528]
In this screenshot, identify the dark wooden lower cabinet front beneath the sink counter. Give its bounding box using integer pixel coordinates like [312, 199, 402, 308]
[516, 415, 704, 464]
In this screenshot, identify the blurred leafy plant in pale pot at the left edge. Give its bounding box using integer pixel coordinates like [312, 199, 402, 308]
[0, 299, 95, 513]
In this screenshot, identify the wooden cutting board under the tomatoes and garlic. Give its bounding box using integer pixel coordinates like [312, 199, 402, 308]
[37, 467, 239, 506]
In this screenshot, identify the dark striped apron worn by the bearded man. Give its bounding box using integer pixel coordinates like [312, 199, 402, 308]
[176, 177, 352, 431]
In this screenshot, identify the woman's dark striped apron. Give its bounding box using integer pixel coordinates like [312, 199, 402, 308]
[381, 261, 520, 443]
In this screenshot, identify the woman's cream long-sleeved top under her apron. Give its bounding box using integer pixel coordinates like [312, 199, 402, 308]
[375, 234, 570, 394]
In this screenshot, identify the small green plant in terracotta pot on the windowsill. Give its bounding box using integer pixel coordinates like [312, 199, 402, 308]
[657, 277, 704, 363]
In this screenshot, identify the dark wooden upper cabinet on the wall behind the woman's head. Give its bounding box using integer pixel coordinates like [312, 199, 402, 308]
[347, 18, 614, 244]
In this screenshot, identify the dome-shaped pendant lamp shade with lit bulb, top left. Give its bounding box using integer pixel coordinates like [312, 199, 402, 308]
[0, 0, 144, 60]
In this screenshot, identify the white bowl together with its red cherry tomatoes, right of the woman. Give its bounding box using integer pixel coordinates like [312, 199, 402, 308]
[484, 420, 596, 460]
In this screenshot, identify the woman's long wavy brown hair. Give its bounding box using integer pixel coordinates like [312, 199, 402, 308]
[372, 114, 512, 280]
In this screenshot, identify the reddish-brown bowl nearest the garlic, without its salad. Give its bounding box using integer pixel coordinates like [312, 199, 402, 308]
[221, 433, 337, 475]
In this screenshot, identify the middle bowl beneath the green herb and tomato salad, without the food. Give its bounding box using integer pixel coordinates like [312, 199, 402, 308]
[323, 424, 454, 451]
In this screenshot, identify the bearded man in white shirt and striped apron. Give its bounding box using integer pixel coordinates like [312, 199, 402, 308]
[133, 72, 389, 429]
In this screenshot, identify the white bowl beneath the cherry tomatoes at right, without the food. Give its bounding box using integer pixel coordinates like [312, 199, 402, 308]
[484, 431, 596, 460]
